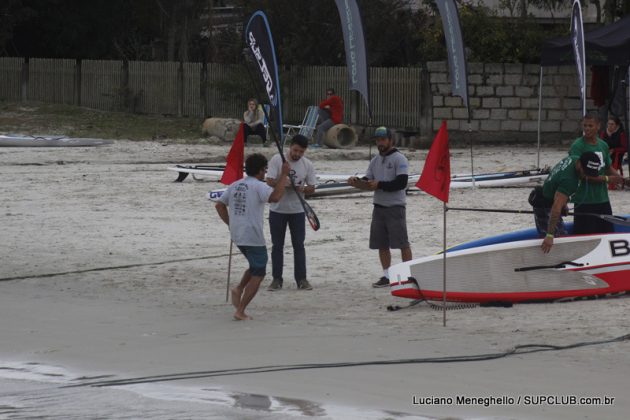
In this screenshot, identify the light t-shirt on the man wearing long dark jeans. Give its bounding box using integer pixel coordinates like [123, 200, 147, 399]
[267, 154, 317, 214]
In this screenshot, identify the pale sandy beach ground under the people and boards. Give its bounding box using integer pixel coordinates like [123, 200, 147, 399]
[0, 141, 630, 419]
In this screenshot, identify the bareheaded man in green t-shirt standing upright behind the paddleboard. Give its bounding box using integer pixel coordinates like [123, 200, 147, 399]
[569, 113, 623, 234]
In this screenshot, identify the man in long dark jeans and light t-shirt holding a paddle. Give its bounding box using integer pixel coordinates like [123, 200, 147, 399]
[267, 134, 317, 291]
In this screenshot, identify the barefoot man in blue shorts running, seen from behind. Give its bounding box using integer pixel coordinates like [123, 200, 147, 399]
[216, 153, 290, 321]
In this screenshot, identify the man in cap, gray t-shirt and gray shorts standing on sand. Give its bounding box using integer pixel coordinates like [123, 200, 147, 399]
[348, 127, 412, 287]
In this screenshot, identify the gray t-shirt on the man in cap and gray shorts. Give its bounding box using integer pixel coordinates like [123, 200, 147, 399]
[365, 149, 409, 207]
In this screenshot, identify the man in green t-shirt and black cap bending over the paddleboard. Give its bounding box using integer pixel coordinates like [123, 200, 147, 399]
[530, 152, 601, 253]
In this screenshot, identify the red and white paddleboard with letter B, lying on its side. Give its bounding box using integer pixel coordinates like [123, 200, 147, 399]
[389, 226, 630, 303]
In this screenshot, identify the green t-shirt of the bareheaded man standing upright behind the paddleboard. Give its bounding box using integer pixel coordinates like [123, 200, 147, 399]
[569, 137, 611, 206]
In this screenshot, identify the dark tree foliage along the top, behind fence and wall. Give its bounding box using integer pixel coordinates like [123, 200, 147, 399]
[0, 0, 630, 66]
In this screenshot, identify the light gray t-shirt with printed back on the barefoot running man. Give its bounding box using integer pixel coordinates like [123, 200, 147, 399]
[219, 176, 273, 246]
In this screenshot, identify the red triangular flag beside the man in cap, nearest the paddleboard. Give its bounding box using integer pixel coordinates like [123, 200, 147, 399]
[416, 121, 451, 203]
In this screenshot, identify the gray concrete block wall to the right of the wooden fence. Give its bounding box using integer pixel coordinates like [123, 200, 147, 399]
[427, 61, 596, 140]
